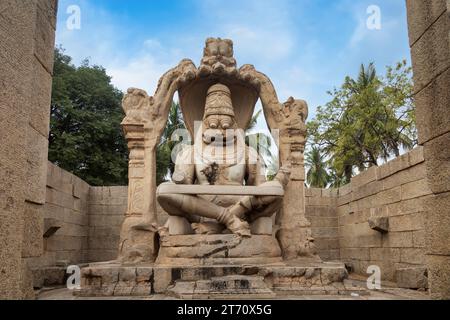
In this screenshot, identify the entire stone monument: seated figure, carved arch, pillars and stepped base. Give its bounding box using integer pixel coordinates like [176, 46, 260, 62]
[82, 38, 347, 298]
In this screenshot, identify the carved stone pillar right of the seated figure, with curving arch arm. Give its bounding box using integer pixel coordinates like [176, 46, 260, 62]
[239, 65, 315, 260]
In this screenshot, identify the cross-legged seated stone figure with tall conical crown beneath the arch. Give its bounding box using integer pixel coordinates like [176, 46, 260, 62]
[157, 83, 289, 237]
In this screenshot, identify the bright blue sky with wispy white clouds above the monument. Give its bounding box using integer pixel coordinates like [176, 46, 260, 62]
[56, 0, 410, 129]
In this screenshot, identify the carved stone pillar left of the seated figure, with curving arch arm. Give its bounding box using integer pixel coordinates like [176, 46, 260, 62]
[118, 59, 197, 263]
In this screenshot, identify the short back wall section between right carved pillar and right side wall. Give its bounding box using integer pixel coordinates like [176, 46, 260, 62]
[305, 188, 339, 261]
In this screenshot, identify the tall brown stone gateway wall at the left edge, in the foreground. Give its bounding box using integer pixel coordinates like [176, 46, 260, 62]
[0, 0, 57, 299]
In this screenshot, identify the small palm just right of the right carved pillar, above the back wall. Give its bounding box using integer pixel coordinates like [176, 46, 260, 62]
[305, 147, 330, 188]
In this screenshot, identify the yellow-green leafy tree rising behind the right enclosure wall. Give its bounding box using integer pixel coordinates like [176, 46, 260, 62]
[308, 61, 417, 182]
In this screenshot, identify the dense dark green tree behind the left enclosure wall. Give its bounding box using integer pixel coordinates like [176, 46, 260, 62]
[49, 48, 128, 185]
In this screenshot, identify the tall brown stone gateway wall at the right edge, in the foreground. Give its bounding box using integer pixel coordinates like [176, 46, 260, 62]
[406, 0, 450, 299]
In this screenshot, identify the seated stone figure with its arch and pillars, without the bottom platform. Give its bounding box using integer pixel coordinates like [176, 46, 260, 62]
[118, 38, 315, 263]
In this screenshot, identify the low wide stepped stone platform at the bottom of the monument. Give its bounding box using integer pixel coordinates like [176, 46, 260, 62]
[74, 259, 349, 299]
